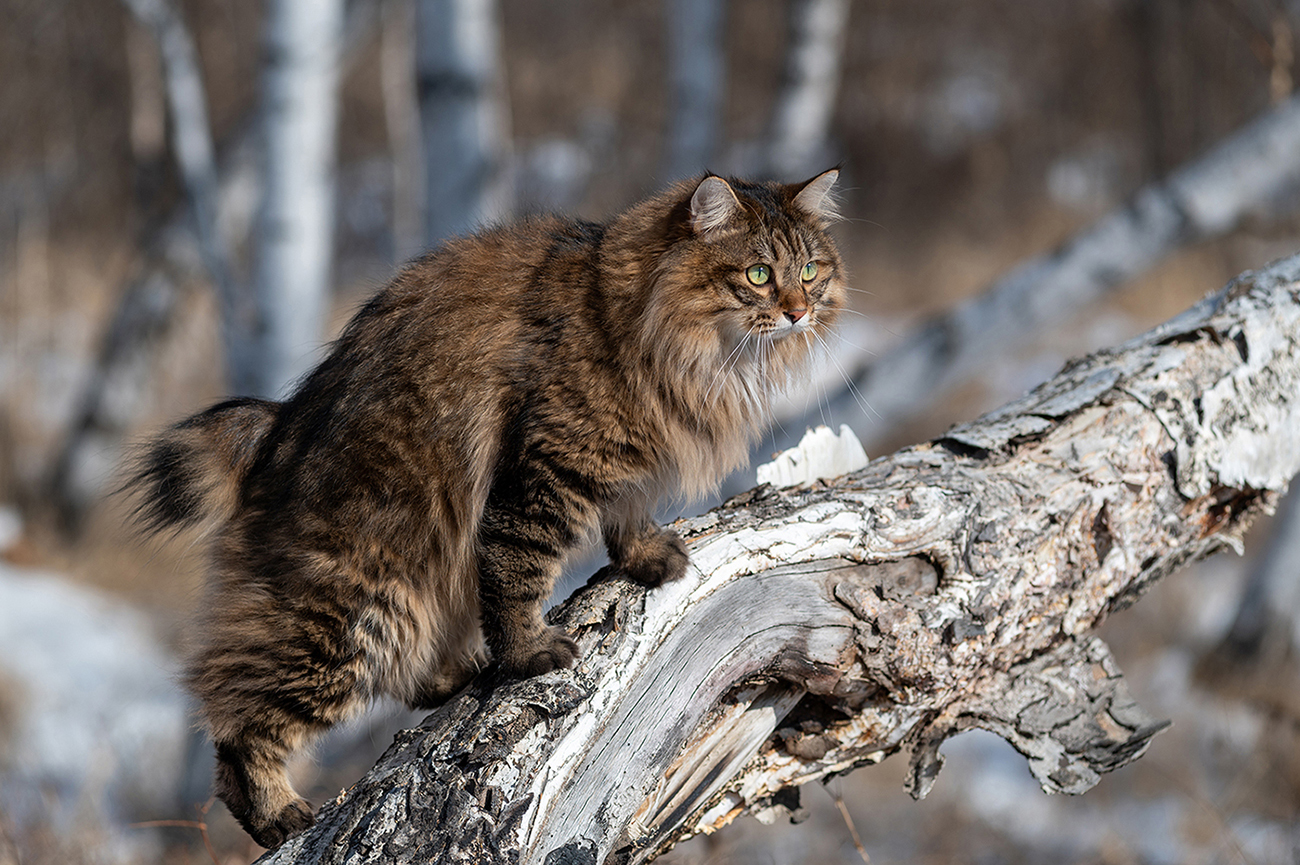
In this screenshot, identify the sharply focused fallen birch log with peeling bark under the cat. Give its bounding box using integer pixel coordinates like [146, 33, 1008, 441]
[263, 256, 1300, 865]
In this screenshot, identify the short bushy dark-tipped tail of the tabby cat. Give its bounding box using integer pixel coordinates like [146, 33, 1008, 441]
[122, 398, 280, 531]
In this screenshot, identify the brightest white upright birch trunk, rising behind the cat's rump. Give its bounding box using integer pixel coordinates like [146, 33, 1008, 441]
[248, 0, 343, 397]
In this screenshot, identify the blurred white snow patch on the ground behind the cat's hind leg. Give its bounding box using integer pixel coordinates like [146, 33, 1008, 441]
[0, 565, 187, 862]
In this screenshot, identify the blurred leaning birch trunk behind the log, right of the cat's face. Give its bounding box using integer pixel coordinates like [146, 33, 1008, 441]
[811, 91, 1300, 451]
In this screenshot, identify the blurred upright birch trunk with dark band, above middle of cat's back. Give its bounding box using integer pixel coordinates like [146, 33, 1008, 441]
[416, 0, 512, 246]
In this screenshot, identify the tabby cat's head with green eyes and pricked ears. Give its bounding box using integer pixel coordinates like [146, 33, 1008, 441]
[657, 169, 848, 372]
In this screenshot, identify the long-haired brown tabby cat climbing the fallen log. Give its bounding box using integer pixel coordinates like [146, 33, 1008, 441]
[129, 170, 846, 847]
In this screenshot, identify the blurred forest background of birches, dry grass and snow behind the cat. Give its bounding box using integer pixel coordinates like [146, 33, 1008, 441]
[0, 0, 1300, 865]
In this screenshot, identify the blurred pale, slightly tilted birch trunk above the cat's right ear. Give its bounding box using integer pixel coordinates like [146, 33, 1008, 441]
[768, 0, 849, 181]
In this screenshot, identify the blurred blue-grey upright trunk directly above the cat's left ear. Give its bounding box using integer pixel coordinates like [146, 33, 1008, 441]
[666, 0, 727, 180]
